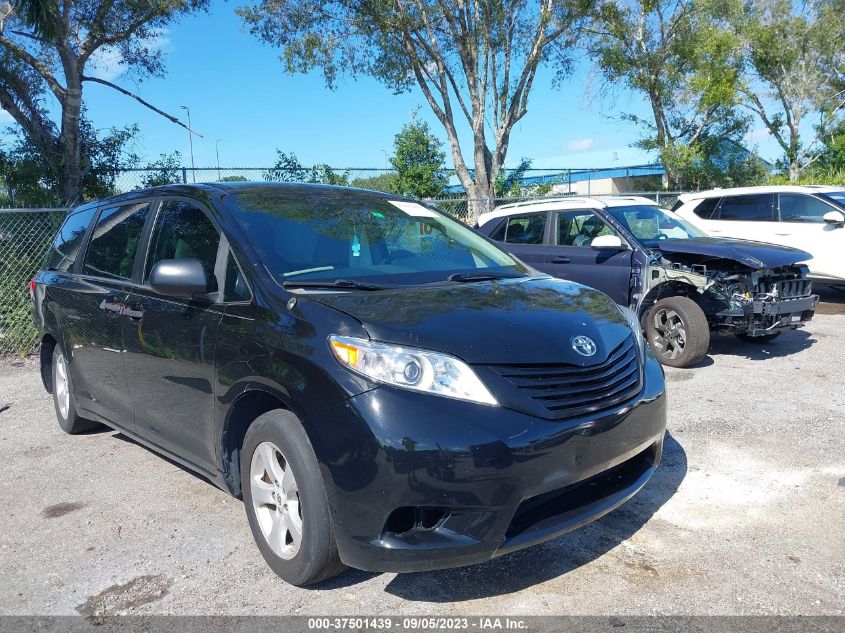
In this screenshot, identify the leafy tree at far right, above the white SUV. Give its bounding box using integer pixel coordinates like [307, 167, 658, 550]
[741, 0, 845, 181]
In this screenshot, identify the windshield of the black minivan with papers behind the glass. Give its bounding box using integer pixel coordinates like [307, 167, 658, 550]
[227, 187, 527, 286]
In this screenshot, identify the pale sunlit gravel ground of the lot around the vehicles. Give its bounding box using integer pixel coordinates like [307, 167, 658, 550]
[0, 308, 845, 615]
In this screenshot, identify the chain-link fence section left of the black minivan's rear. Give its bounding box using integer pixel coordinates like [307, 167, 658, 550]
[0, 209, 66, 354]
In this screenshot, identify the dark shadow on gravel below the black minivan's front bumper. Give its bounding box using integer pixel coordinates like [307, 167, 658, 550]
[360, 433, 687, 602]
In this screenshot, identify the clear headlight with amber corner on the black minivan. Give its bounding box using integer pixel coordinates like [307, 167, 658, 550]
[329, 336, 499, 405]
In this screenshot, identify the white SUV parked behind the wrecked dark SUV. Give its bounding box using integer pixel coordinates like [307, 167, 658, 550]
[672, 185, 845, 284]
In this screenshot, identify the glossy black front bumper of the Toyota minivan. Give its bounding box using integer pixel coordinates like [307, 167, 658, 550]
[304, 350, 666, 572]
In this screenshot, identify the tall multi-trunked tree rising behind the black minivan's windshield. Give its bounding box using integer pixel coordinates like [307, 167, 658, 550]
[238, 0, 592, 219]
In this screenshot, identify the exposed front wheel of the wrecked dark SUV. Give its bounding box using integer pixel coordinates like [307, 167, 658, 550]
[646, 297, 710, 367]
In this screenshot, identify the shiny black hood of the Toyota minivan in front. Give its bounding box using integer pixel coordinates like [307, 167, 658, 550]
[308, 278, 630, 366]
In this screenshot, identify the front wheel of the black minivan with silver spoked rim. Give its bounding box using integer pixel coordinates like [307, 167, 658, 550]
[241, 411, 345, 586]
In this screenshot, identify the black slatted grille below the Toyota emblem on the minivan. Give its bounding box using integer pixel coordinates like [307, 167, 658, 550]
[493, 336, 642, 419]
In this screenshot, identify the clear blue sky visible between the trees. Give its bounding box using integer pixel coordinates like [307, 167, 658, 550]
[0, 1, 777, 168]
